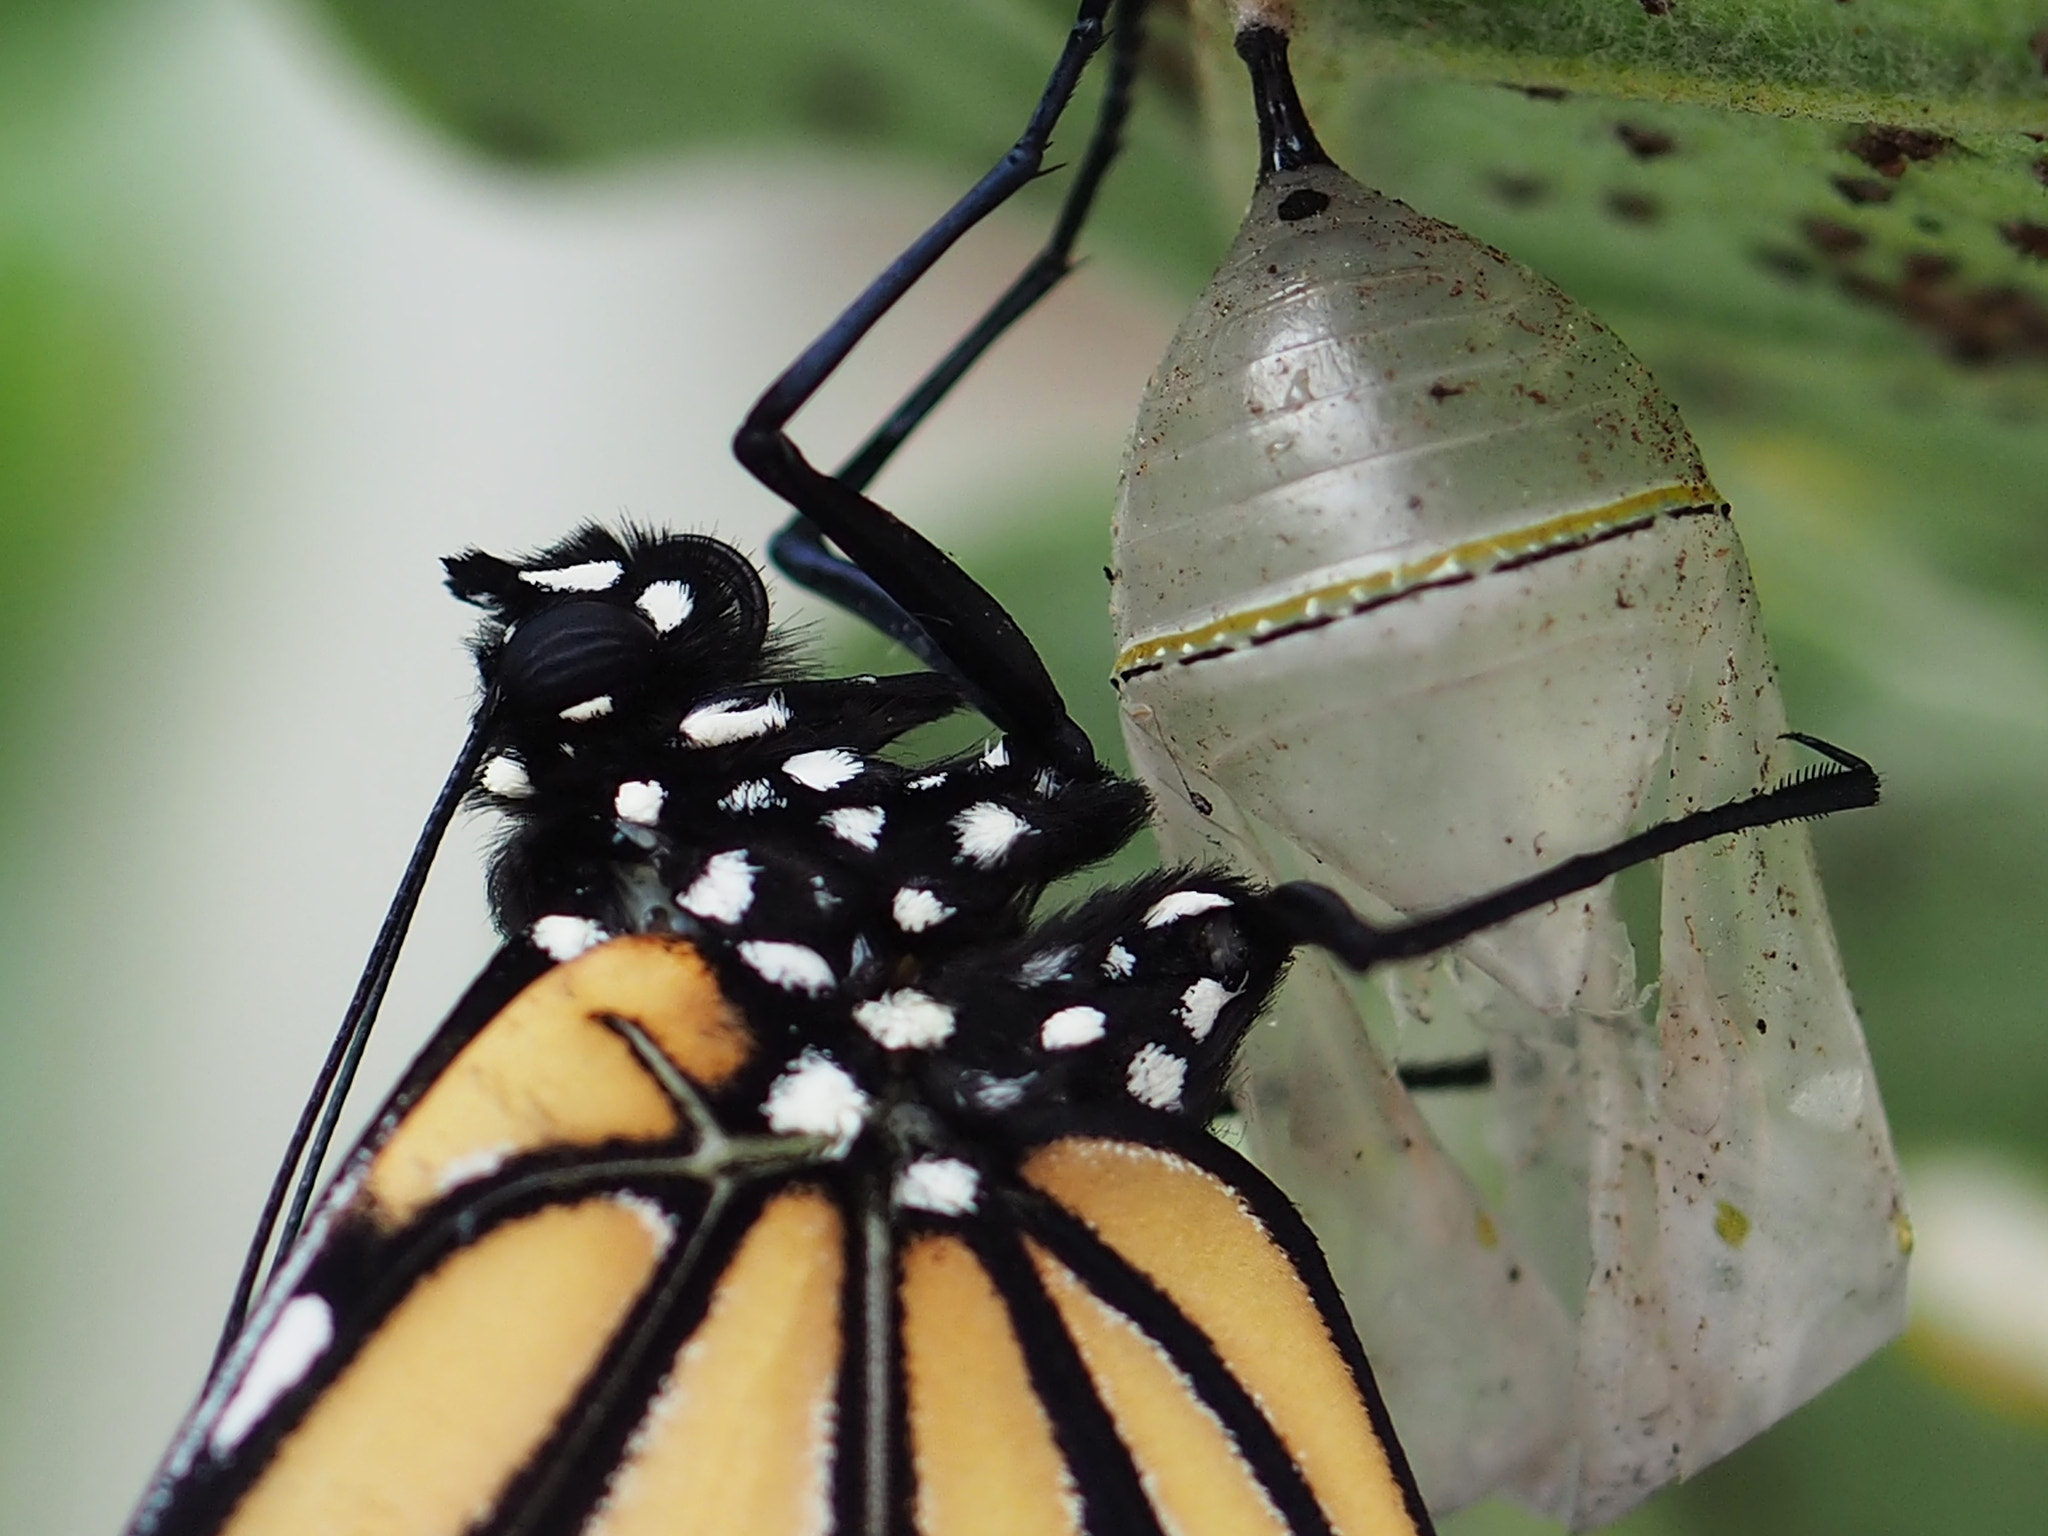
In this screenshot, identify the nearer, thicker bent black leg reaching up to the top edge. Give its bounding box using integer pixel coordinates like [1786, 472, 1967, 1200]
[733, 0, 1112, 772]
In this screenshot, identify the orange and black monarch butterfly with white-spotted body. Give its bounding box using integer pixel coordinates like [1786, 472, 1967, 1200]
[131, 0, 1876, 1536]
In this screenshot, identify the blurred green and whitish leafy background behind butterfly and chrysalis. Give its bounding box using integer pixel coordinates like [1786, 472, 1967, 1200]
[0, 0, 2048, 1536]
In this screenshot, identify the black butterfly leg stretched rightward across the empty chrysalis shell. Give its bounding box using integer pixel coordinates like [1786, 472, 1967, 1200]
[1257, 731, 1878, 971]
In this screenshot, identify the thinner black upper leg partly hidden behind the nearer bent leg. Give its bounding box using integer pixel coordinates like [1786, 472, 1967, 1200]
[768, 0, 1147, 672]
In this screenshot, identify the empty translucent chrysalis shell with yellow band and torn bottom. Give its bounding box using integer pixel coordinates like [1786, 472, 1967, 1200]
[1112, 166, 1909, 1526]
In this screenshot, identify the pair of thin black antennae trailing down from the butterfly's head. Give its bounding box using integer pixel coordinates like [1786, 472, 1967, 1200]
[213, 716, 494, 1370]
